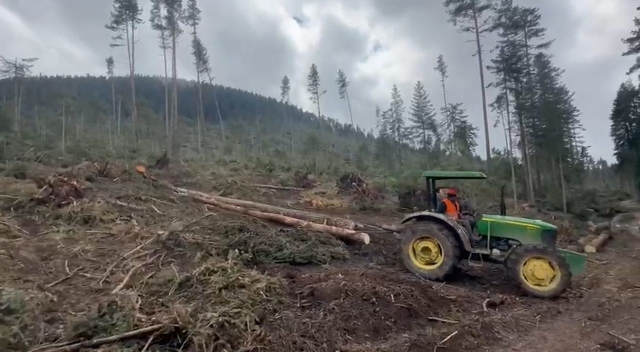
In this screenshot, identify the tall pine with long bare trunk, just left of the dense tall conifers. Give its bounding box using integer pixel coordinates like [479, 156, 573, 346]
[444, 0, 494, 161]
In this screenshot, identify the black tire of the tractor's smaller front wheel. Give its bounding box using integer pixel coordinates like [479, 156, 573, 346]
[505, 246, 571, 299]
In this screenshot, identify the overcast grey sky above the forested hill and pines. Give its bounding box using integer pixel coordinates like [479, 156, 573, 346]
[0, 0, 638, 161]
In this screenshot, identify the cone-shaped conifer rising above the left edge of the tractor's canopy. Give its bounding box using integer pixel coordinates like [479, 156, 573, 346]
[409, 81, 439, 151]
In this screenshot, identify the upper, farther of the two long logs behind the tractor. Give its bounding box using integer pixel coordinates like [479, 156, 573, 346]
[172, 187, 364, 230]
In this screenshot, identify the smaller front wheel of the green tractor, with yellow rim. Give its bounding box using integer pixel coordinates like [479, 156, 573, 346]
[505, 246, 571, 298]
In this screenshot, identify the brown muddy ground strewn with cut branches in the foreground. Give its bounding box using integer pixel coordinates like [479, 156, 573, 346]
[0, 164, 640, 352]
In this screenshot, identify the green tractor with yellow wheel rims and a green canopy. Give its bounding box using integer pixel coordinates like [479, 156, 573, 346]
[401, 171, 587, 298]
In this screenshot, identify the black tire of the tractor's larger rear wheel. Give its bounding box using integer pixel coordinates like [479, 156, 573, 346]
[400, 221, 460, 281]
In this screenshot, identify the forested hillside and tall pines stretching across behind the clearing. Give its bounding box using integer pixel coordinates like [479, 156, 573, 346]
[2, 0, 632, 207]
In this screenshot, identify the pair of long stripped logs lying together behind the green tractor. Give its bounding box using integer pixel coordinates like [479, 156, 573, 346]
[136, 166, 370, 244]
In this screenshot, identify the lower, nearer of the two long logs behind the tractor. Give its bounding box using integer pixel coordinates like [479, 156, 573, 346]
[194, 195, 371, 244]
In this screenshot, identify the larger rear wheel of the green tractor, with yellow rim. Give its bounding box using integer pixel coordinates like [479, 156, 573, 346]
[400, 221, 460, 281]
